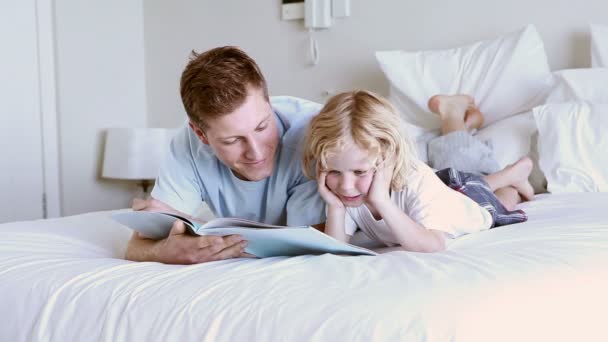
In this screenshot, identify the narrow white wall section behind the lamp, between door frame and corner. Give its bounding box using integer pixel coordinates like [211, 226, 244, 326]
[55, 0, 146, 215]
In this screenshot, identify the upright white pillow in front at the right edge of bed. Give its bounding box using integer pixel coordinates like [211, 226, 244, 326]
[534, 102, 608, 193]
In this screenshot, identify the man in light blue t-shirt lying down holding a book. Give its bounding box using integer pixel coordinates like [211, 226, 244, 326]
[126, 47, 325, 264]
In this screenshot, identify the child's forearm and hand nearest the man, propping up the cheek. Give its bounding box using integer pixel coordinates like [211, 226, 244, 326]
[317, 172, 350, 242]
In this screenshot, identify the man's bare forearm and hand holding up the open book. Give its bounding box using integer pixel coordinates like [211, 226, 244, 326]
[125, 198, 247, 264]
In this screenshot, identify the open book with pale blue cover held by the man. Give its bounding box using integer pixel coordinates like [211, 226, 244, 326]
[112, 211, 378, 258]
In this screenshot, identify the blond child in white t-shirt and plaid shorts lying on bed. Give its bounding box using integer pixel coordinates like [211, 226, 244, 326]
[303, 91, 527, 252]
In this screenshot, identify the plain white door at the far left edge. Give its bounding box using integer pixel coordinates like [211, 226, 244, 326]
[0, 0, 44, 222]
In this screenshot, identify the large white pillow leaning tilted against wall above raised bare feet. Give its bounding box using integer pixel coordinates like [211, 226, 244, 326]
[376, 25, 551, 130]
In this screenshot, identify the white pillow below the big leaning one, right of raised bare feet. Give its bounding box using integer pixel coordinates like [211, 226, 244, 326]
[475, 111, 547, 194]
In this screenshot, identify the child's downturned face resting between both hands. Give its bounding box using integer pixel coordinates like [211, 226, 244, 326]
[325, 144, 375, 207]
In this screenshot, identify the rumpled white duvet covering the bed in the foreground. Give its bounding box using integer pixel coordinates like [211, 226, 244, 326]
[0, 193, 608, 341]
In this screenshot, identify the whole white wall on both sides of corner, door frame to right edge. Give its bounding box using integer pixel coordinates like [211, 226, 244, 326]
[39, 0, 608, 215]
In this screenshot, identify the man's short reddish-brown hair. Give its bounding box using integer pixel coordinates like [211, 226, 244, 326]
[180, 46, 268, 128]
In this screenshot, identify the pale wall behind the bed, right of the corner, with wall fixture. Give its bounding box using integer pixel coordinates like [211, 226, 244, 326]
[144, 0, 608, 127]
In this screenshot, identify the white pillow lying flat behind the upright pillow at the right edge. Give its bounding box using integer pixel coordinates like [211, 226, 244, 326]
[546, 68, 608, 103]
